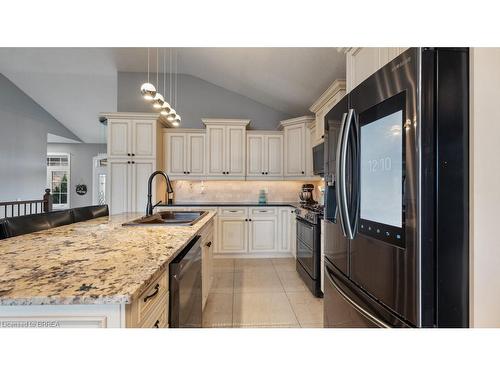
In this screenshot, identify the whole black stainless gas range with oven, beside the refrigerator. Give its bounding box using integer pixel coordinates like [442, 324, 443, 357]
[295, 204, 324, 297]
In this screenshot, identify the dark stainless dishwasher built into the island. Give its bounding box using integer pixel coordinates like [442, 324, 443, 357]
[169, 236, 202, 328]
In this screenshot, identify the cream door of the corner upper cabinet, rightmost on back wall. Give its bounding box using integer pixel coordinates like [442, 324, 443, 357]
[285, 124, 306, 177]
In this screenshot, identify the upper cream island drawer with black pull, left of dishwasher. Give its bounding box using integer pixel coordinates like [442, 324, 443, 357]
[128, 271, 168, 327]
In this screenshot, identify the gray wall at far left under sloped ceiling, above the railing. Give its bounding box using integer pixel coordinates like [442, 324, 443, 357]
[0, 74, 79, 201]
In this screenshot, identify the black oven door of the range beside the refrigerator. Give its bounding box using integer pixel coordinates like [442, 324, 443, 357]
[297, 217, 319, 280]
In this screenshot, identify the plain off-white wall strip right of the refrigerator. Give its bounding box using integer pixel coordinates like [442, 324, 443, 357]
[470, 48, 500, 327]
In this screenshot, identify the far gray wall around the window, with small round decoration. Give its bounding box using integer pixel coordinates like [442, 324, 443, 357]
[47, 143, 106, 208]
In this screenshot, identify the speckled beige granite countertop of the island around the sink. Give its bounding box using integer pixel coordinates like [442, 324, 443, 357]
[0, 211, 215, 305]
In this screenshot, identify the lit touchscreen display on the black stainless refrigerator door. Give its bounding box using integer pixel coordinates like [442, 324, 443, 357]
[360, 110, 403, 231]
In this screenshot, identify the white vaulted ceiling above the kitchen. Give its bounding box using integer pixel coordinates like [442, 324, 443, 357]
[0, 48, 345, 142]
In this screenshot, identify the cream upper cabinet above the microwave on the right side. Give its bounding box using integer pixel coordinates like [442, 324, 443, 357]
[309, 79, 346, 145]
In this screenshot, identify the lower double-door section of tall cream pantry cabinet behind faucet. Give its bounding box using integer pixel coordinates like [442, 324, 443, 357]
[107, 159, 156, 214]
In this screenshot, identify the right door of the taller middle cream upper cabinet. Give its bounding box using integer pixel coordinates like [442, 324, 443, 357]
[225, 126, 246, 176]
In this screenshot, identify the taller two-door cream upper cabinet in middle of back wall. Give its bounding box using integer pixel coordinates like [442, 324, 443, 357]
[202, 119, 250, 179]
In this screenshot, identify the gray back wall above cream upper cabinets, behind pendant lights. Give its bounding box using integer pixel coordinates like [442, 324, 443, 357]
[118, 72, 293, 130]
